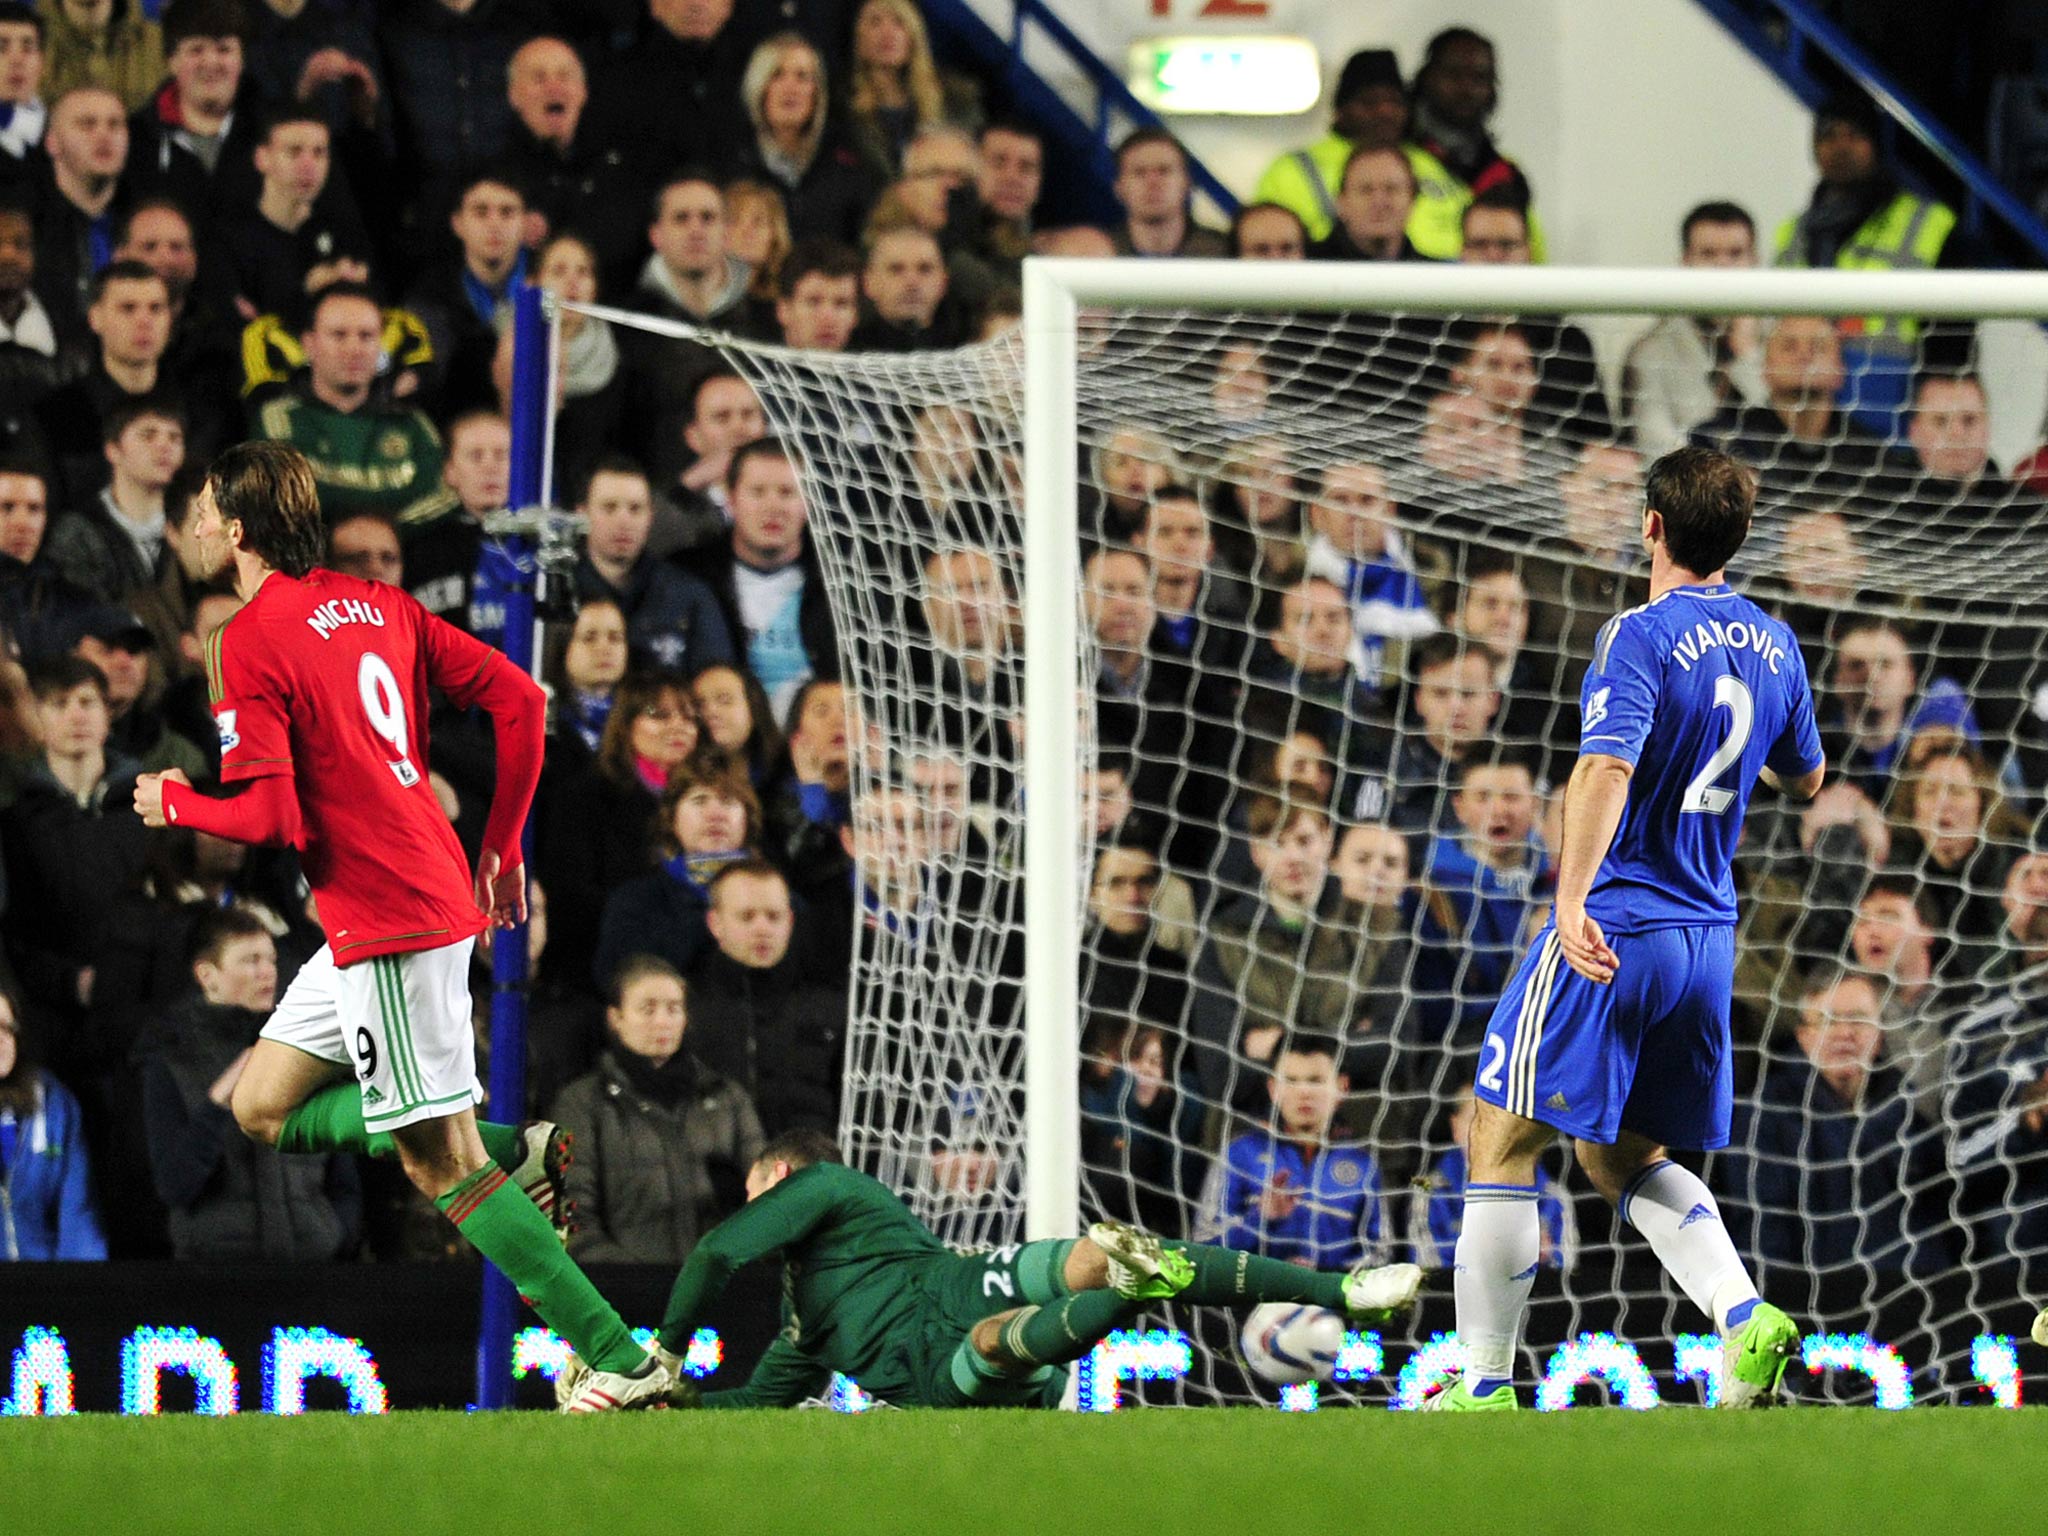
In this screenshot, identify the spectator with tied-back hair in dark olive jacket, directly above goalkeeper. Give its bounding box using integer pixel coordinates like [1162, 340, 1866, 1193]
[549, 954, 762, 1266]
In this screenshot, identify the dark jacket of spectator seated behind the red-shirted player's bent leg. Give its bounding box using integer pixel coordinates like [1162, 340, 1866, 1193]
[139, 997, 362, 1262]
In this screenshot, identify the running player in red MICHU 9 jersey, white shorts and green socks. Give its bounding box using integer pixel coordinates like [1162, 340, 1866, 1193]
[135, 442, 672, 1411]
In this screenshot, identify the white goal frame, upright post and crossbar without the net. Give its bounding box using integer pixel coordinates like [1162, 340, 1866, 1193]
[1024, 256, 2048, 1239]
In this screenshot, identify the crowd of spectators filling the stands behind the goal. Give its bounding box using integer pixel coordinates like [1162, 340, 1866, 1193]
[0, 0, 2048, 1351]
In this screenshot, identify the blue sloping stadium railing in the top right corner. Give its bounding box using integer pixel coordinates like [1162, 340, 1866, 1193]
[1698, 0, 2048, 266]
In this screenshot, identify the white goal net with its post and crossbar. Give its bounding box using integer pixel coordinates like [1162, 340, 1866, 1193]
[569, 262, 2048, 1407]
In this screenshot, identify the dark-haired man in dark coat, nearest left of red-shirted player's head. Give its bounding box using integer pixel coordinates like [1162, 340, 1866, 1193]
[49, 395, 184, 602]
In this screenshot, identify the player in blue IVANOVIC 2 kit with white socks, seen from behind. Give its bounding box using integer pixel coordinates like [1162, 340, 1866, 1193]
[1430, 446, 1827, 1411]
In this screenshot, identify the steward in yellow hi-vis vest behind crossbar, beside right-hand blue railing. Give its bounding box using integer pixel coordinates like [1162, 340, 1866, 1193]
[1776, 96, 1976, 436]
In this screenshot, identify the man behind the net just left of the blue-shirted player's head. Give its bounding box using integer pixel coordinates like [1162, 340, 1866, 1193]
[1522, 442, 1649, 679]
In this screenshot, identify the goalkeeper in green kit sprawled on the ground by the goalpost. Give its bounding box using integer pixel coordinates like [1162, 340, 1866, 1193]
[557, 1130, 1421, 1407]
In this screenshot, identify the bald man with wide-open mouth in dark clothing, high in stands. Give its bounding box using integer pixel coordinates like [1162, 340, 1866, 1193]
[502, 37, 647, 289]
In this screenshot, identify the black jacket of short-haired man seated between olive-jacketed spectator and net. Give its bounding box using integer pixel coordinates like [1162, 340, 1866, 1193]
[688, 944, 846, 1137]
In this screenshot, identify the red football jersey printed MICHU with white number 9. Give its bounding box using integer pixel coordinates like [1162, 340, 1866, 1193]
[207, 569, 510, 965]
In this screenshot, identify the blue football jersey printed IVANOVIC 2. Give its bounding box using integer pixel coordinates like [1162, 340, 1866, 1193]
[1579, 584, 1823, 934]
